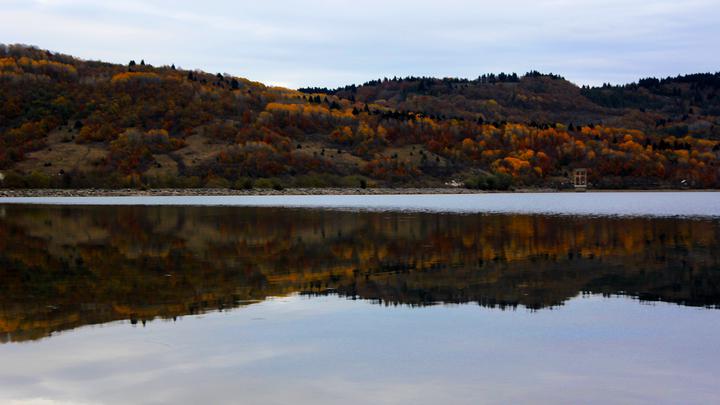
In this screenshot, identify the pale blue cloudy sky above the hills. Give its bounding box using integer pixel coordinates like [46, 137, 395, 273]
[0, 0, 720, 88]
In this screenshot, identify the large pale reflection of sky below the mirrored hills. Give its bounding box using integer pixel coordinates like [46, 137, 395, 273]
[0, 297, 720, 404]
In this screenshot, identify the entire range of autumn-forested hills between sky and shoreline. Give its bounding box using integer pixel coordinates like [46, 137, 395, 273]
[0, 45, 720, 188]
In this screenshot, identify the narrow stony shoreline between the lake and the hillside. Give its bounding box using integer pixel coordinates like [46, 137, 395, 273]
[0, 188, 720, 198]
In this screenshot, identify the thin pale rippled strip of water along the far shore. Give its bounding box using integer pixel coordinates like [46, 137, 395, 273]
[0, 192, 720, 217]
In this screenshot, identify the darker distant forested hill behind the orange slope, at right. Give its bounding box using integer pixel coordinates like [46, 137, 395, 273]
[300, 72, 720, 139]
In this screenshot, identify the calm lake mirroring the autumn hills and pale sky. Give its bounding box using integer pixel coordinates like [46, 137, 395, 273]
[0, 193, 720, 404]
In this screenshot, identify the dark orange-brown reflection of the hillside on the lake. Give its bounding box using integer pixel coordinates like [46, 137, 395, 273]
[0, 206, 720, 340]
